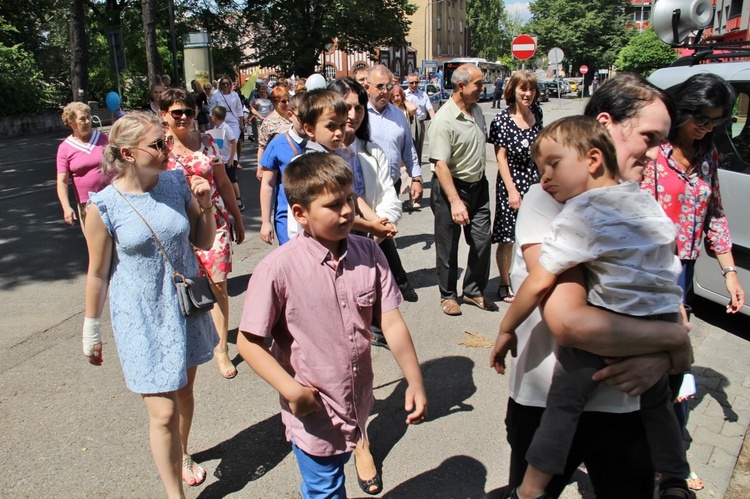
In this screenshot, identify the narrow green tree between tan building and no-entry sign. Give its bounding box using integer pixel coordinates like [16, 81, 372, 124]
[466, 0, 508, 61]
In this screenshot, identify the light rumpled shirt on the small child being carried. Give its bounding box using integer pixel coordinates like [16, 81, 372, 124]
[539, 181, 682, 316]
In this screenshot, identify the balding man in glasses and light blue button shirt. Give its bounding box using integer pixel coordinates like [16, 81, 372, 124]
[365, 64, 422, 201]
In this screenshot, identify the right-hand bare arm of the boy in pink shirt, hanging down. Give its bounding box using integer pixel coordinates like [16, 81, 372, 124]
[380, 308, 427, 424]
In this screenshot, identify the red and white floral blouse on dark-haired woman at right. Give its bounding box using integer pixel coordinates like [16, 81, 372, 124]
[641, 142, 732, 260]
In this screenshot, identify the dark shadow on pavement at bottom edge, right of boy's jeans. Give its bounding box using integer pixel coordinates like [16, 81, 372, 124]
[383, 456, 487, 498]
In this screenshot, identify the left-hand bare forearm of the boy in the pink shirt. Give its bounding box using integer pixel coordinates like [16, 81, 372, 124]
[237, 331, 320, 417]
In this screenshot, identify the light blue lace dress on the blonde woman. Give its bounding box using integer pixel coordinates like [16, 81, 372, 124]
[91, 171, 219, 393]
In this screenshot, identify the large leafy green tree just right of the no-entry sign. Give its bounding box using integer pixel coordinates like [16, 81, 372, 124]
[529, 0, 632, 73]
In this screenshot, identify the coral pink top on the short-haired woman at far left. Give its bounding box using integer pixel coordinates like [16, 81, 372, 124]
[57, 130, 109, 203]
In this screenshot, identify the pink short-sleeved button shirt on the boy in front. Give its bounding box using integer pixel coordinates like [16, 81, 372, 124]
[240, 232, 402, 456]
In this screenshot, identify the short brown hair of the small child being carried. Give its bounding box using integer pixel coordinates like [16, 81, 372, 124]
[531, 116, 620, 178]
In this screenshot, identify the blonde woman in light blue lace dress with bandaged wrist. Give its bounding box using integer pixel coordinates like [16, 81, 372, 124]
[83, 112, 218, 497]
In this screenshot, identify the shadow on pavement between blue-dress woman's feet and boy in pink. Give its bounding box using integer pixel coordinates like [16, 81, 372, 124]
[193, 414, 292, 499]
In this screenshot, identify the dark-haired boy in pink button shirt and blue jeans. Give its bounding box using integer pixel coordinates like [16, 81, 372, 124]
[237, 153, 427, 498]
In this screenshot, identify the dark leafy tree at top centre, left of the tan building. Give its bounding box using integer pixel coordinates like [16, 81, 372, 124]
[244, 0, 416, 76]
